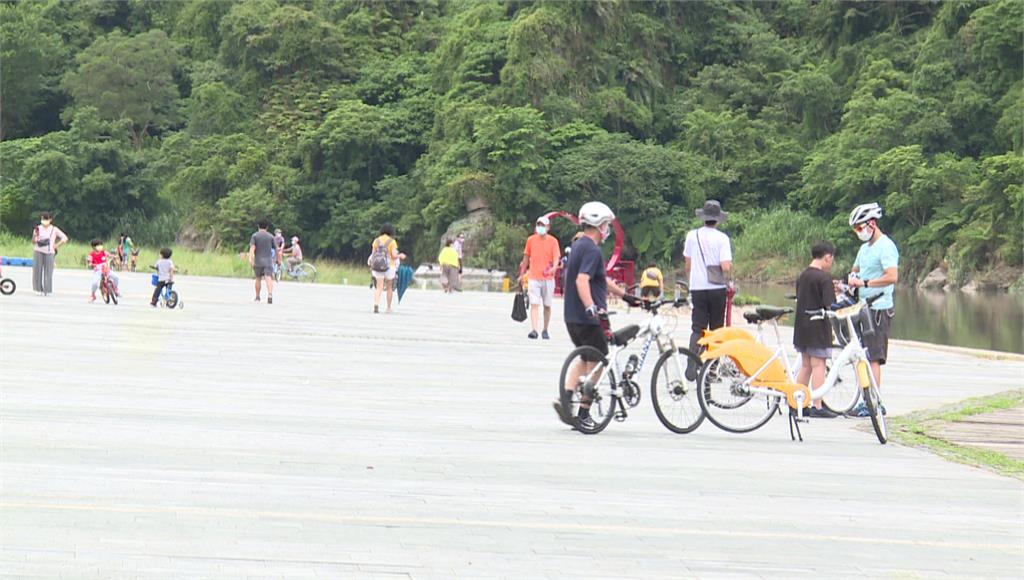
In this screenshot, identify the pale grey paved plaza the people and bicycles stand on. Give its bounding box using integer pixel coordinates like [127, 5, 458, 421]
[0, 268, 1024, 578]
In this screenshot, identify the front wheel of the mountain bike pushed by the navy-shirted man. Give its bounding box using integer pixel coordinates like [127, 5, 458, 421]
[650, 346, 705, 433]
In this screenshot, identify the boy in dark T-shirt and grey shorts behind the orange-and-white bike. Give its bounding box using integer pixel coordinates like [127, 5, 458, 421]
[793, 242, 837, 419]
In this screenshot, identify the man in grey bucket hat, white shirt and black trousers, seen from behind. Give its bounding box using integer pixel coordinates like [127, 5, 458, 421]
[683, 200, 732, 380]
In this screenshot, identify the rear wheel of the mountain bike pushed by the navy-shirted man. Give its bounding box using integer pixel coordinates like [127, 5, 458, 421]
[558, 346, 615, 434]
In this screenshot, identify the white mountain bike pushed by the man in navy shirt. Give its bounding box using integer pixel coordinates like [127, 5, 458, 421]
[558, 299, 703, 434]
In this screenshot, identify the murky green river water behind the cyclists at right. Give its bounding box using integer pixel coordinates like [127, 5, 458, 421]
[739, 284, 1024, 354]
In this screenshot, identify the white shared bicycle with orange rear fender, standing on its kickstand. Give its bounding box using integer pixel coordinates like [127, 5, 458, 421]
[697, 297, 889, 444]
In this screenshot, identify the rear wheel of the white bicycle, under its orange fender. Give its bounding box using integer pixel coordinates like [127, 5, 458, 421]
[697, 357, 784, 433]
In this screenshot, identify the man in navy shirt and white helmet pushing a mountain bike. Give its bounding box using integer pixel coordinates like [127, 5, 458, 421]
[555, 202, 640, 427]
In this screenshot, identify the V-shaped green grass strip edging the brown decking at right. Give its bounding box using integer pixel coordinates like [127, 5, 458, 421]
[890, 390, 1024, 480]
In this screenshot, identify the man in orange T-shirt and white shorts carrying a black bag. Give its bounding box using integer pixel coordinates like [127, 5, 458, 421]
[519, 215, 562, 340]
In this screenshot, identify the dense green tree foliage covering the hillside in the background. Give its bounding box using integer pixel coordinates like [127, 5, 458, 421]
[0, 0, 1024, 282]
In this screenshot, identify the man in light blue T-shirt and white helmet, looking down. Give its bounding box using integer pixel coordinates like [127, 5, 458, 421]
[849, 203, 899, 416]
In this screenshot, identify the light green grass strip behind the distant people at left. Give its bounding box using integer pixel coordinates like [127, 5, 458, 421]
[0, 234, 370, 285]
